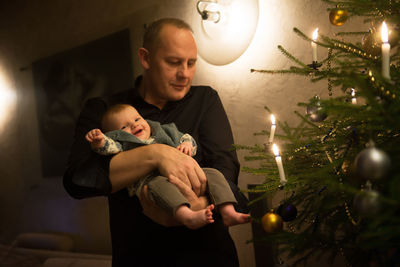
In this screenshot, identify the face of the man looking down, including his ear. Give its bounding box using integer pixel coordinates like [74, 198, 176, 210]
[145, 25, 197, 106]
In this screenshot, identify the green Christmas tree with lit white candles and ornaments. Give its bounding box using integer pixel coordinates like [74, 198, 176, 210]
[246, 0, 400, 266]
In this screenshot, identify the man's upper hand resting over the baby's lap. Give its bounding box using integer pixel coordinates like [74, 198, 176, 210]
[156, 145, 207, 196]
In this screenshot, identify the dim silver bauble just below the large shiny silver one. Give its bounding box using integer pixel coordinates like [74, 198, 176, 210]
[353, 190, 381, 217]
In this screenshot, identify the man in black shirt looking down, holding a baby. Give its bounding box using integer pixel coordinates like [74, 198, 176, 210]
[64, 19, 246, 267]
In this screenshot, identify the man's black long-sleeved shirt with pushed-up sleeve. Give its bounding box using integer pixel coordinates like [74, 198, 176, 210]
[64, 76, 246, 267]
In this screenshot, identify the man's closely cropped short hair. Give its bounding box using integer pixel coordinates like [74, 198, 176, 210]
[143, 18, 193, 51]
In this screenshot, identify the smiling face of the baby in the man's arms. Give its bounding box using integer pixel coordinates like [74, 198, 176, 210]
[108, 107, 151, 140]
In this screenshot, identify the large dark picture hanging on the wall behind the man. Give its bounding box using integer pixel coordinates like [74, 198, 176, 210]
[32, 29, 134, 177]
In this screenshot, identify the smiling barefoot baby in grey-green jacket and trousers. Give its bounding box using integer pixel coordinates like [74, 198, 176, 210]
[86, 104, 250, 229]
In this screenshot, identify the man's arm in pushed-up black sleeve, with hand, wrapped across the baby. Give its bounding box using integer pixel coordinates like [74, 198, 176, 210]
[64, 98, 206, 198]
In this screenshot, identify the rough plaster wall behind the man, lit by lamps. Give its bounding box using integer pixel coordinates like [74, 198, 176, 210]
[0, 0, 364, 267]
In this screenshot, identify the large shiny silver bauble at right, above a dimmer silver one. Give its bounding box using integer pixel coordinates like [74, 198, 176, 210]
[354, 147, 390, 181]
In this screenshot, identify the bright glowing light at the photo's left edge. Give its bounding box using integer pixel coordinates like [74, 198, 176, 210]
[0, 69, 16, 132]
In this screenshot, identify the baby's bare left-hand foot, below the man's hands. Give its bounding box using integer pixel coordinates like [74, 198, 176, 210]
[175, 204, 214, 229]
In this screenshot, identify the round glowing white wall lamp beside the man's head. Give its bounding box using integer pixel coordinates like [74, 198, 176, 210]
[193, 0, 258, 65]
